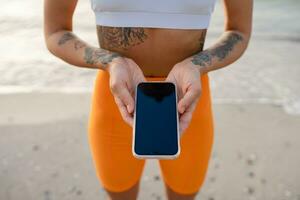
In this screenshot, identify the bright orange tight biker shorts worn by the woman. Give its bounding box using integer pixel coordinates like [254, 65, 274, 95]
[88, 70, 213, 194]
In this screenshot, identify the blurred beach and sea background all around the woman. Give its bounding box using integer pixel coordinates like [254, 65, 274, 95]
[0, 0, 300, 200]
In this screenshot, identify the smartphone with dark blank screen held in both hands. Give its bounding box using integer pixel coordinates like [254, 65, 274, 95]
[132, 81, 180, 159]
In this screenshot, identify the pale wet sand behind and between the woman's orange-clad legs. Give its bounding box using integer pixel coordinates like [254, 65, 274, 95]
[0, 93, 300, 200]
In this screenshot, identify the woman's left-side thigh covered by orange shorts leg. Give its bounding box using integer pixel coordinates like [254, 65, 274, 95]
[88, 71, 145, 192]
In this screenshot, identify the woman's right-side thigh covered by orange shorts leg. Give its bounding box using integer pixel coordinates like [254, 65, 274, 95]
[159, 75, 213, 195]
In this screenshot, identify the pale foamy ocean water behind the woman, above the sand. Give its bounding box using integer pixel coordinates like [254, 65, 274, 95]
[0, 0, 300, 114]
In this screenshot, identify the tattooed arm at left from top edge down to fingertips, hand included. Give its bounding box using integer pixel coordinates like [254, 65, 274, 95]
[44, 0, 145, 126]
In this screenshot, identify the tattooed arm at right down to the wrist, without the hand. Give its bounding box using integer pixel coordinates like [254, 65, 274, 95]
[188, 0, 253, 73]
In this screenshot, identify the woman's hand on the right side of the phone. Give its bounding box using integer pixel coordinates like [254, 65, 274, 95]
[165, 59, 201, 136]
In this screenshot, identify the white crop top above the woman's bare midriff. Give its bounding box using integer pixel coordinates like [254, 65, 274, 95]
[90, 0, 216, 29]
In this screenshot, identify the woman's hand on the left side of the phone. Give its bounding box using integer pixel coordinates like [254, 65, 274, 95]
[106, 57, 146, 126]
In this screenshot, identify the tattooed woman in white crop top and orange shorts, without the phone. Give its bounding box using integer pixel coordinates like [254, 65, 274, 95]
[44, 0, 253, 200]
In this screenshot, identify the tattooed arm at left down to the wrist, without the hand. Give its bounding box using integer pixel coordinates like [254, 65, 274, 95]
[44, 0, 121, 69]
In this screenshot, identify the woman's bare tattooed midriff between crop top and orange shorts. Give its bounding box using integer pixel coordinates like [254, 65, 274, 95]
[97, 25, 206, 77]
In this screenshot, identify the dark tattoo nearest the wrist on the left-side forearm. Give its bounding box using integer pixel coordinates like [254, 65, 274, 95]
[84, 47, 121, 65]
